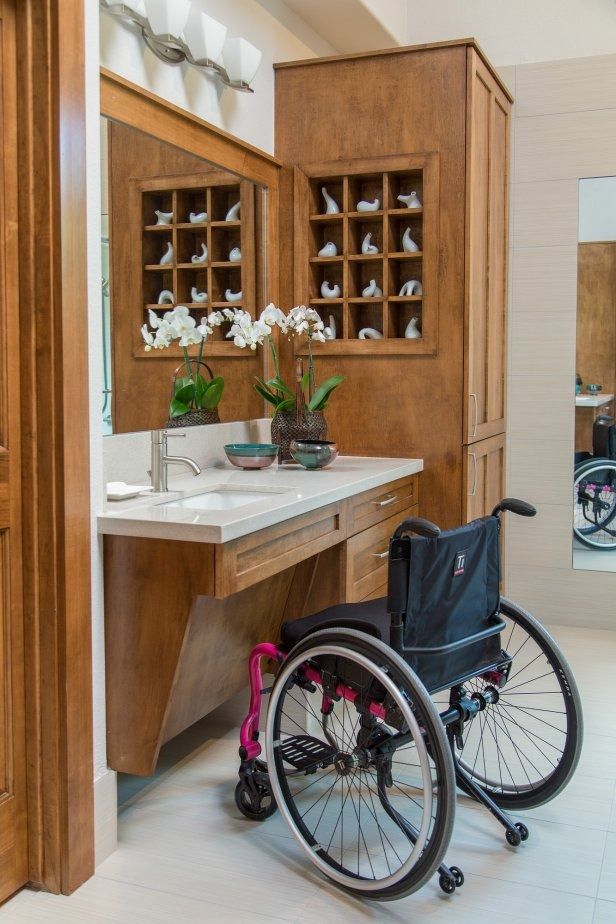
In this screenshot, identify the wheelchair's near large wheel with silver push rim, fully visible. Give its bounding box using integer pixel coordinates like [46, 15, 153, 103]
[266, 629, 455, 899]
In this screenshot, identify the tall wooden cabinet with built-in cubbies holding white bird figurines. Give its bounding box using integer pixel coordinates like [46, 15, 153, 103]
[276, 40, 512, 527]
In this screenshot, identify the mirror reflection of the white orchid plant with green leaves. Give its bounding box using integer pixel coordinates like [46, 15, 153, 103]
[141, 305, 226, 417]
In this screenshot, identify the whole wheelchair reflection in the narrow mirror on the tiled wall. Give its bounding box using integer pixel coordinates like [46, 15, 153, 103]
[573, 414, 616, 549]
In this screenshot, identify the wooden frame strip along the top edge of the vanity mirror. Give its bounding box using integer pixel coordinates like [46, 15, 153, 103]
[101, 68, 282, 186]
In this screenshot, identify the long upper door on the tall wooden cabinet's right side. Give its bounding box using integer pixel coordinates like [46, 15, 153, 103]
[464, 50, 509, 443]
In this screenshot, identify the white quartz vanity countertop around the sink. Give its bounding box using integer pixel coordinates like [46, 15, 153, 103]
[98, 456, 423, 543]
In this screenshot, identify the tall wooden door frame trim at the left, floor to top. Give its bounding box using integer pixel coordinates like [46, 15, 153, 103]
[17, 0, 94, 893]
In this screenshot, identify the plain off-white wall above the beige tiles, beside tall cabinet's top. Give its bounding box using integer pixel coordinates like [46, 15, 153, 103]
[406, 0, 616, 66]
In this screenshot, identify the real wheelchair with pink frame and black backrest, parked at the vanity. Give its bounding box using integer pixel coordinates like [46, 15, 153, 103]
[235, 498, 583, 900]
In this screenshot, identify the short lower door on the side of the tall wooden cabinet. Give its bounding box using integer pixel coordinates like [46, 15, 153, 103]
[463, 433, 505, 523]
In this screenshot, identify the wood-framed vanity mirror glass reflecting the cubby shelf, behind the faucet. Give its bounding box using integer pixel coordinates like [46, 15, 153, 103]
[101, 117, 267, 434]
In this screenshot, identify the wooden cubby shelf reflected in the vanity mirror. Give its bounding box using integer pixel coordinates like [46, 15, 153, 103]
[134, 171, 257, 359]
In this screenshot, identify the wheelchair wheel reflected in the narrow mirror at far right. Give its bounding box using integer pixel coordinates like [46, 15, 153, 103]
[573, 458, 616, 551]
